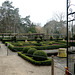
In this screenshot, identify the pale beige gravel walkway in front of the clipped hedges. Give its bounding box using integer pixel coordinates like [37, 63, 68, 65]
[0, 43, 64, 75]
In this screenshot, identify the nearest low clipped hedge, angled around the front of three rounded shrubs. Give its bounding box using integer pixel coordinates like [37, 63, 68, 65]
[18, 52, 51, 66]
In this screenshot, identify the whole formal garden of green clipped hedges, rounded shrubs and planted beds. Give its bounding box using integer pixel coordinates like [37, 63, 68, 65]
[1, 35, 75, 65]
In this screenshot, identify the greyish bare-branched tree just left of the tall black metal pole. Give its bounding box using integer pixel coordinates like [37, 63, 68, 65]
[44, 12, 66, 35]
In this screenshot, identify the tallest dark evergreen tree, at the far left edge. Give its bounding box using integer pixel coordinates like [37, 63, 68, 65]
[0, 1, 20, 32]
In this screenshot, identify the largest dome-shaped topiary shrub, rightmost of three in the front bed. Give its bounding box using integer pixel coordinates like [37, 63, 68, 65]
[33, 50, 47, 61]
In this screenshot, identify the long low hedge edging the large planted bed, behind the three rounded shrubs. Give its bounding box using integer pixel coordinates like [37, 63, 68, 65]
[5, 42, 67, 51]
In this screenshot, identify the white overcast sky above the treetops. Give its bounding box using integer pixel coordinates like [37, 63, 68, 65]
[0, 0, 75, 26]
